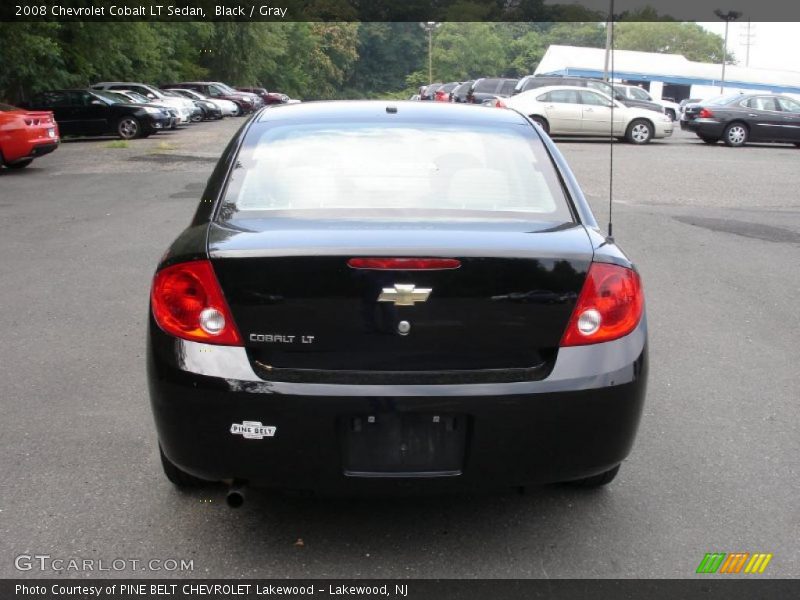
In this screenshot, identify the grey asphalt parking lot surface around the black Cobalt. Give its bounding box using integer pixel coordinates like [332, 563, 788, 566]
[0, 119, 800, 578]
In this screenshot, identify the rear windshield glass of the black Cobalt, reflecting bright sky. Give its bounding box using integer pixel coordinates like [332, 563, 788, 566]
[222, 122, 572, 223]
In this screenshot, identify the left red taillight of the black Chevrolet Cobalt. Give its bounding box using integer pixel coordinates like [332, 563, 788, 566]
[150, 260, 242, 346]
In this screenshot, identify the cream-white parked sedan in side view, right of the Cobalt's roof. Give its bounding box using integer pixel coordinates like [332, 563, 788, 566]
[501, 86, 672, 144]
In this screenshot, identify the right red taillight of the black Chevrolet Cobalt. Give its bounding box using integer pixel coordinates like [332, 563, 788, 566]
[561, 263, 644, 346]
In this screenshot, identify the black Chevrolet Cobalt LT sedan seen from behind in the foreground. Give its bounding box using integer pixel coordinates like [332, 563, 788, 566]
[148, 101, 647, 504]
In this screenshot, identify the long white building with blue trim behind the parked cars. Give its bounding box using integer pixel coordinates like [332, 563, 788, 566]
[534, 45, 800, 102]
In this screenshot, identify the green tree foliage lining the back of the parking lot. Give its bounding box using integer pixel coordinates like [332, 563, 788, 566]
[0, 21, 733, 101]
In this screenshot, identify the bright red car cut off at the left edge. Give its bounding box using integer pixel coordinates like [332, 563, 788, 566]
[0, 104, 61, 169]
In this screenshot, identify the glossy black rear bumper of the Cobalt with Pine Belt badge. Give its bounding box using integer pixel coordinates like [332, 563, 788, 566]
[148, 318, 647, 494]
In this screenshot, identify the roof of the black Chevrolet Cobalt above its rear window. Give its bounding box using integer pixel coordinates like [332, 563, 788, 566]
[256, 100, 528, 125]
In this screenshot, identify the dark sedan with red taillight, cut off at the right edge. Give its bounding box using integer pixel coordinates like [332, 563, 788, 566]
[684, 93, 800, 147]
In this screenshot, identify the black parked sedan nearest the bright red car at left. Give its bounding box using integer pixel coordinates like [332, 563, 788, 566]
[27, 90, 171, 140]
